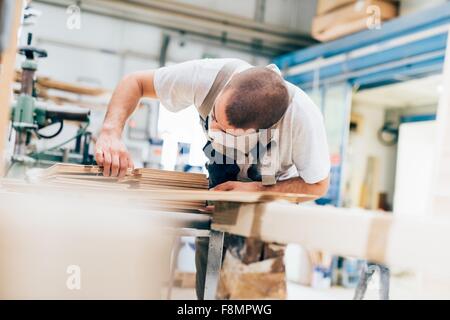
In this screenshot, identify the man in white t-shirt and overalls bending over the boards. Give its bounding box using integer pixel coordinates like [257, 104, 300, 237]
[96, 59, 330, 299]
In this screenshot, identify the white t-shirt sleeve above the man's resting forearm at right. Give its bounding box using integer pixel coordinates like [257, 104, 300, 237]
[292, 94, 330, 184]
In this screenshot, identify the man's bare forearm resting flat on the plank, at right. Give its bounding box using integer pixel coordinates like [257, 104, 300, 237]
[263, 178, 329, 198]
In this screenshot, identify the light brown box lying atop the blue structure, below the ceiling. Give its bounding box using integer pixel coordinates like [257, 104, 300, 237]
[312, 0, 398, 41]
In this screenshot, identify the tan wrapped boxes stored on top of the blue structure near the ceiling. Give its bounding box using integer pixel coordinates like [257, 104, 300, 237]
[312, 0, 398, 42]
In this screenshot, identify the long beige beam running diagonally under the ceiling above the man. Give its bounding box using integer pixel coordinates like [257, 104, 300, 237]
[36, 0, 315, 57]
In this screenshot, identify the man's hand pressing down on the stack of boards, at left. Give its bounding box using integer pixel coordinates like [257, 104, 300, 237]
[95, 132, 134, 178]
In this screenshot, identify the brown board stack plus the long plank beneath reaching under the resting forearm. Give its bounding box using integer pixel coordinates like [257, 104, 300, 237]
[29, 164, 314, 203]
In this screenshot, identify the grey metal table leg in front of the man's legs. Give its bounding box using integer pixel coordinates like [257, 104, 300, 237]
[204, 230, 224, 300]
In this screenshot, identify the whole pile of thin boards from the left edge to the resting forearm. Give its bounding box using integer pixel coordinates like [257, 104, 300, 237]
[0, 164, 314, 213]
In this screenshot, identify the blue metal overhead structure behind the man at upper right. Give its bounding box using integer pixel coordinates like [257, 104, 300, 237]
[273, 3, 450, 206]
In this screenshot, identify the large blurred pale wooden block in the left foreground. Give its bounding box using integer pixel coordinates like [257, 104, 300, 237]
[0, 188, 215, 299]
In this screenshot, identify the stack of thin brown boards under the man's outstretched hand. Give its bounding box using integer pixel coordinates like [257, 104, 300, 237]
[32, 164, 208, 212]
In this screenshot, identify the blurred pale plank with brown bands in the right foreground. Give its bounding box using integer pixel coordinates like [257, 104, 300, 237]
[211, 203, 450, 281]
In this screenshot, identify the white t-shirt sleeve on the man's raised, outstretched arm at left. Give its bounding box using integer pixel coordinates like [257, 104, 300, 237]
[154, 60, 200, 112]
